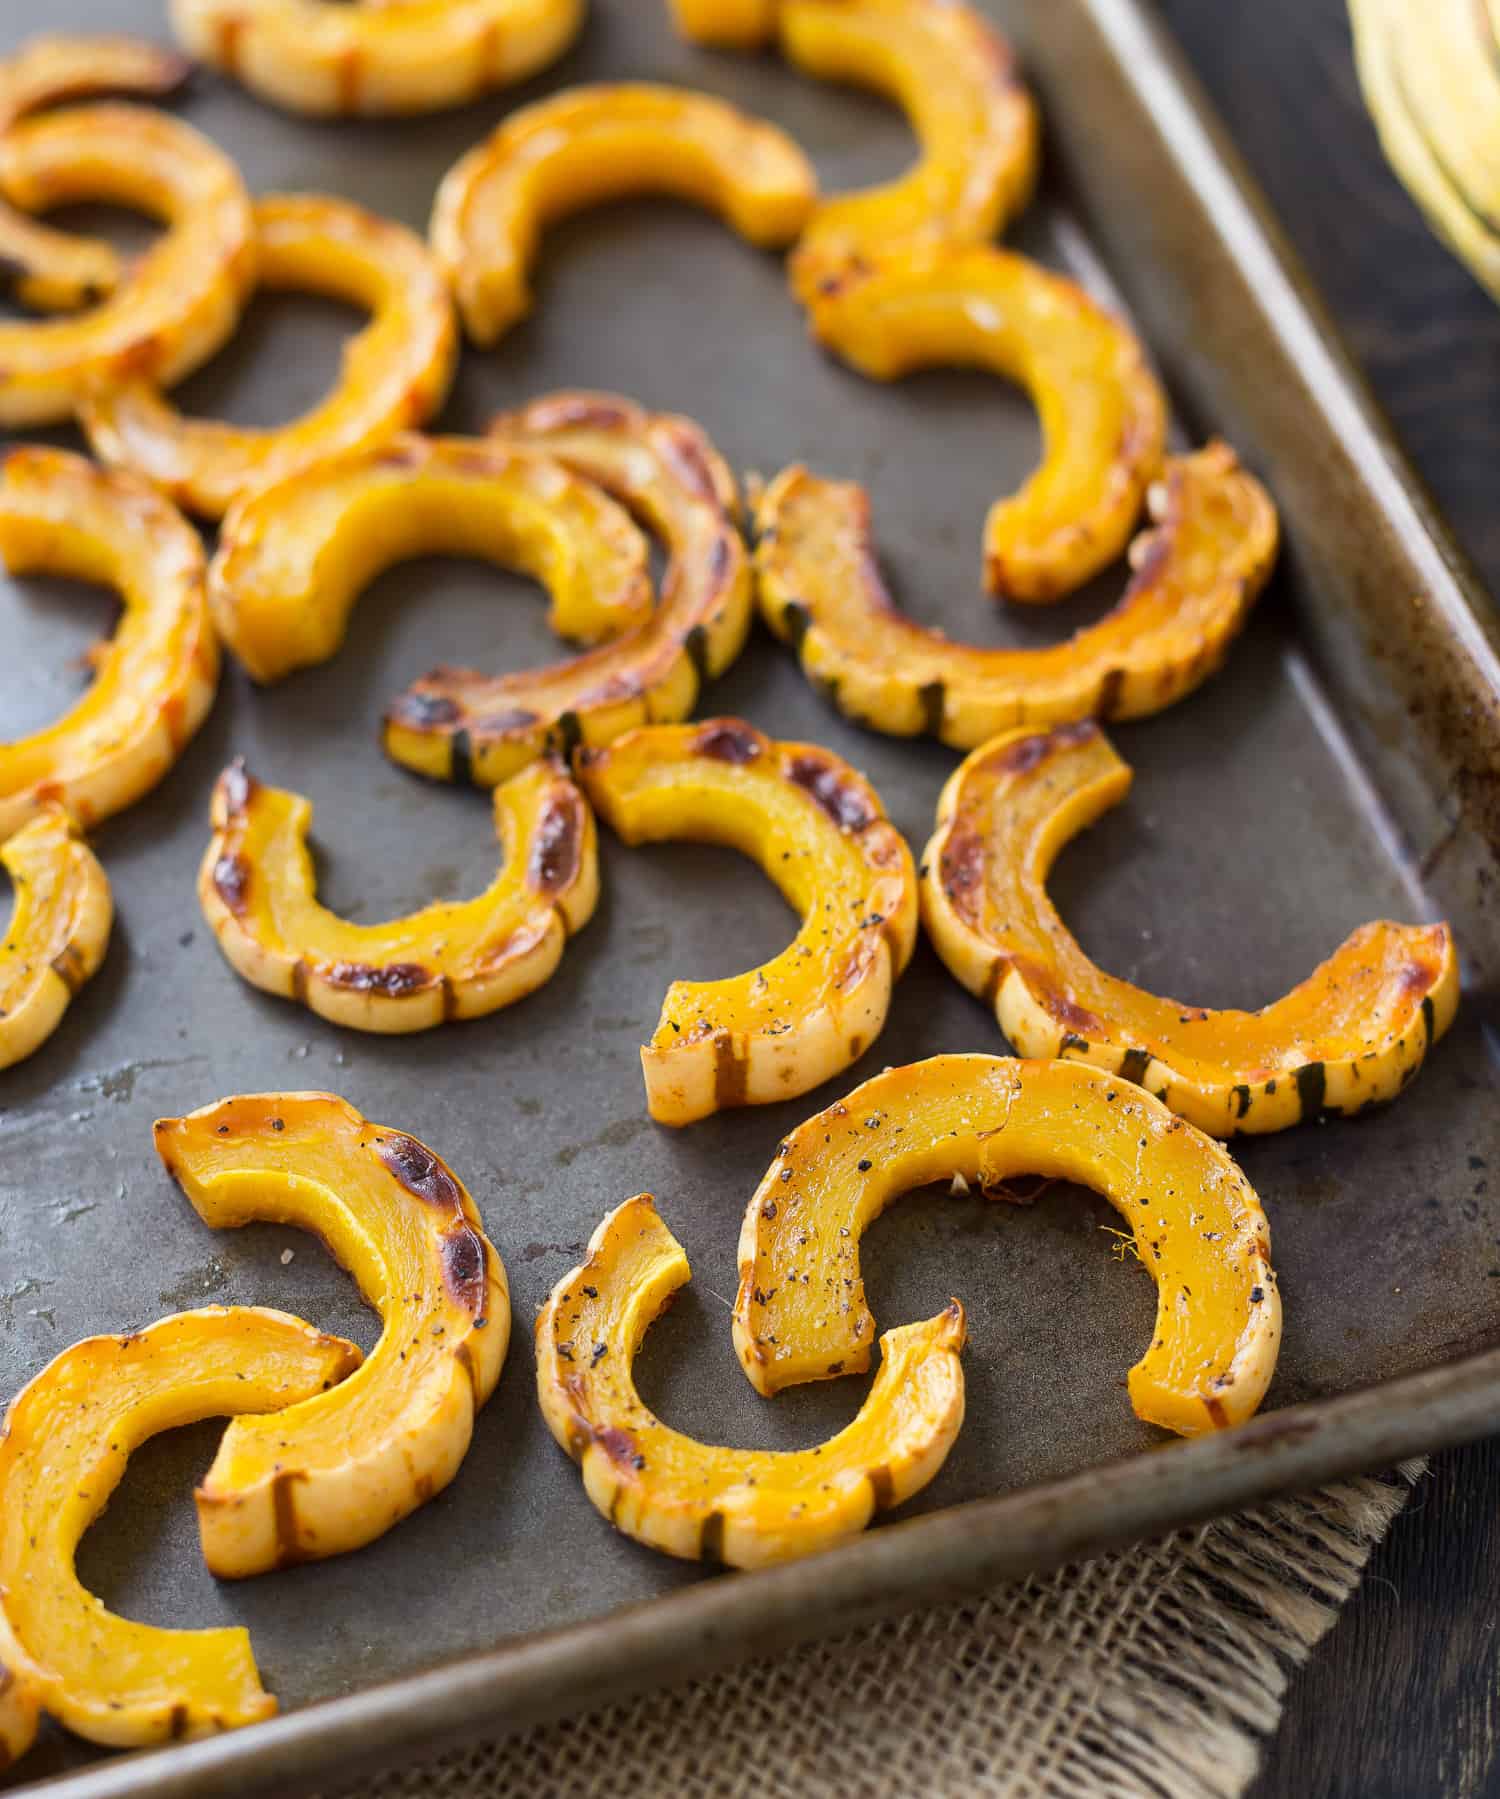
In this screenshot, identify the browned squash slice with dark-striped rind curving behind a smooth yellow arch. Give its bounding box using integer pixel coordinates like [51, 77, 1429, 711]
[385, 392, 752, 786]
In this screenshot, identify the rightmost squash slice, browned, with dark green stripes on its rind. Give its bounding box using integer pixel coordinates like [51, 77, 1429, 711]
[923, 723, 1459, 1137]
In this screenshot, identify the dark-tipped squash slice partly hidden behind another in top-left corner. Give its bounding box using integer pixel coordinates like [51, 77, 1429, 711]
[0, 38, 192, 313]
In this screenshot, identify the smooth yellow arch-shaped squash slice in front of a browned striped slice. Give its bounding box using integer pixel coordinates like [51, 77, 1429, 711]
[209, 434, 651, 687]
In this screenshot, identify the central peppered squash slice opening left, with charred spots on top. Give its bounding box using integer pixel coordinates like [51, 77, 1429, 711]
[577, 718, 917, 1124]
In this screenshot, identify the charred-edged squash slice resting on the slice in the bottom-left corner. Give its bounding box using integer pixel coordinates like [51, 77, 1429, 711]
[156, 1094, 511, 1580]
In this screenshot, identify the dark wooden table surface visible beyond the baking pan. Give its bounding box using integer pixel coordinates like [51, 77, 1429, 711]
[1158, 0, 1500, 1799]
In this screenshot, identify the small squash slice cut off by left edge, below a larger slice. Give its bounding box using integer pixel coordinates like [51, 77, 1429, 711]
[0, 806, 115, 1069]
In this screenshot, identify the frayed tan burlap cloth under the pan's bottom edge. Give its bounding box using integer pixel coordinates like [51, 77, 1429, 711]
[340, 1464, 1421, 1799]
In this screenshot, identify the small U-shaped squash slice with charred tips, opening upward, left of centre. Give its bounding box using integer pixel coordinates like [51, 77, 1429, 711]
[198, 759, 599, 1033]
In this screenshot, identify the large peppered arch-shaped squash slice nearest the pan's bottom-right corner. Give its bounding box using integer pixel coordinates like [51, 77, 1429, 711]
[734, 1056, 1281, 1436]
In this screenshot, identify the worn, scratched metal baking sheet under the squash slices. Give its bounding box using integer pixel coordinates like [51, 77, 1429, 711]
[0, 0, 1500, 1795]
